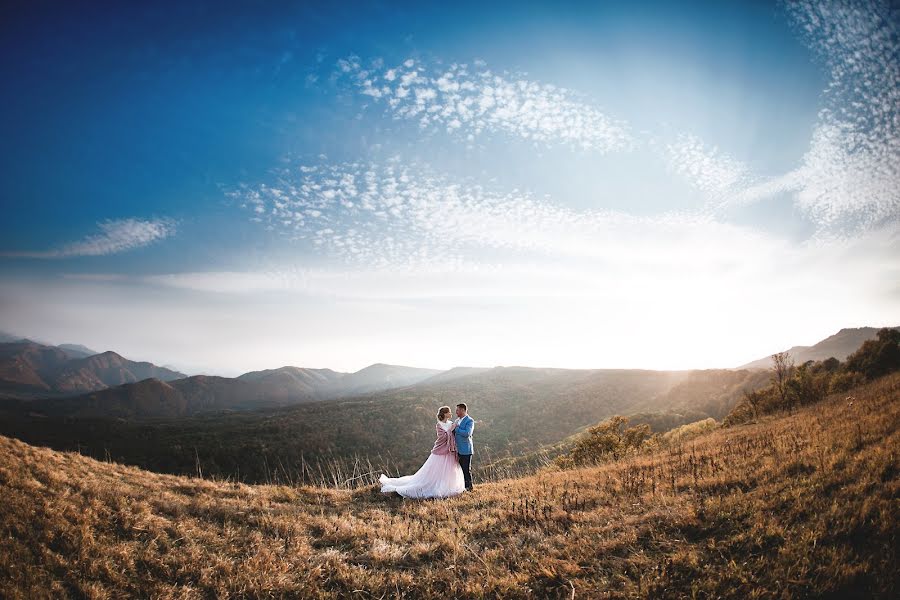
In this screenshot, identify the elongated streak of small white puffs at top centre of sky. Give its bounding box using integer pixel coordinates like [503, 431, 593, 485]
[337, 57, 634, 153]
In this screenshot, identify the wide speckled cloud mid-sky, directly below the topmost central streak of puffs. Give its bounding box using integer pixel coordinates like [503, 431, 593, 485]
[233, 161, 732, 267]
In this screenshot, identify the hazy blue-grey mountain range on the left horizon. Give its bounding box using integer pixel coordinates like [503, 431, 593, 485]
[0, 339, 441, 418]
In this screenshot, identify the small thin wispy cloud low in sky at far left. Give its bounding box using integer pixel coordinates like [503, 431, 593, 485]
[2, 219, 175, 258]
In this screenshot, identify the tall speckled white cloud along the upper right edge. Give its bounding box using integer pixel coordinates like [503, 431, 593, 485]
[726, 0, 900, 237]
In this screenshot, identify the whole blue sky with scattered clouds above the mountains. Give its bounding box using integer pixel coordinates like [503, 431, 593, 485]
[0, 0, 900, 375]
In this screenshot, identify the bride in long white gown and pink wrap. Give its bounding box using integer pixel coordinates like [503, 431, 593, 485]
[379, 406, 466, 498]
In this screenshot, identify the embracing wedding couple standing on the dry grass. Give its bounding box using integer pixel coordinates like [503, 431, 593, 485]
[379, 403, 475, 498]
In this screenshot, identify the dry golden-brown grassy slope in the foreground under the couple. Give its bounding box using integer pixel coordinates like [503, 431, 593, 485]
[0, 374, 900, 598]
